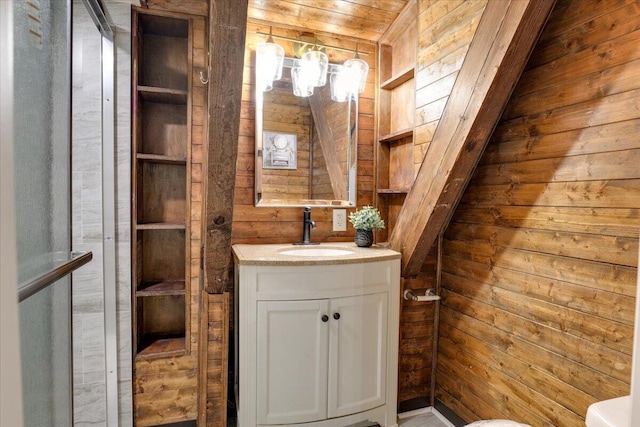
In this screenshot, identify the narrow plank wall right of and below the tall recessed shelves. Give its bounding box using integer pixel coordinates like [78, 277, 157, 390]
[133, 5, 207, 426]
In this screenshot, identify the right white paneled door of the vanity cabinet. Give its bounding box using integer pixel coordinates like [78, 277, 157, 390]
[328, 292, 384, 418]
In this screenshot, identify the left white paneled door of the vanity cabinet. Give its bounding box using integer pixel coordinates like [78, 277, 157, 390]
[257, 299, 333, 424]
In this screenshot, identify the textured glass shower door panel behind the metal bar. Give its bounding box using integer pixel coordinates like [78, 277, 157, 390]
[11, 0, 73, 427]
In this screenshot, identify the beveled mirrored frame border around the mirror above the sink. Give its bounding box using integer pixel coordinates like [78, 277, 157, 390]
[254, 57, 358, 208]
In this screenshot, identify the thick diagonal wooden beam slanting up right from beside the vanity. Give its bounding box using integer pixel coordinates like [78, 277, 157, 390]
[389, 0, 555, 277]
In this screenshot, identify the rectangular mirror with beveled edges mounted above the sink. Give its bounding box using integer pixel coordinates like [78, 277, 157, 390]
[255, 58, 358, 206]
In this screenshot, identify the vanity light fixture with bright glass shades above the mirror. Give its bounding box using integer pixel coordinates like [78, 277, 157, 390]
[256, 30, 369, 102]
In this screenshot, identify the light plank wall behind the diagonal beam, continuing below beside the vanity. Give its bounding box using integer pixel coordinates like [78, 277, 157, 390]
[398, 0, 487, 405]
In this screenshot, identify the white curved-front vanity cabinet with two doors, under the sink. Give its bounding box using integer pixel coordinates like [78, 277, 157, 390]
[234, 244, 400, 427]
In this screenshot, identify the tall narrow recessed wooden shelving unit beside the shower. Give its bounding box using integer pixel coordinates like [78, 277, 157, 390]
[132, 10, 191, 358]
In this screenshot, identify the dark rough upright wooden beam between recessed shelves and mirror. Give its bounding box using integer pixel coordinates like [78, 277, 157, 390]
[203, 0, 248, 293]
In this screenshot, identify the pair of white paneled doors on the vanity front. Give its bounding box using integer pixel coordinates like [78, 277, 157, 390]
[257, 292, 388, 424]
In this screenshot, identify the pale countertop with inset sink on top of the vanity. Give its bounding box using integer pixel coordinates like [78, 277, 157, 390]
[232, 242, 400, 265]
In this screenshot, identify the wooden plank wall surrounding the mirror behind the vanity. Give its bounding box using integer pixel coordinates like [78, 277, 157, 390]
[232, 20, 377, 243]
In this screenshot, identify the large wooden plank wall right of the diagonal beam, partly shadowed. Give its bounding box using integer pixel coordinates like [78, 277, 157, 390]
[436, 0, 640, 427]
